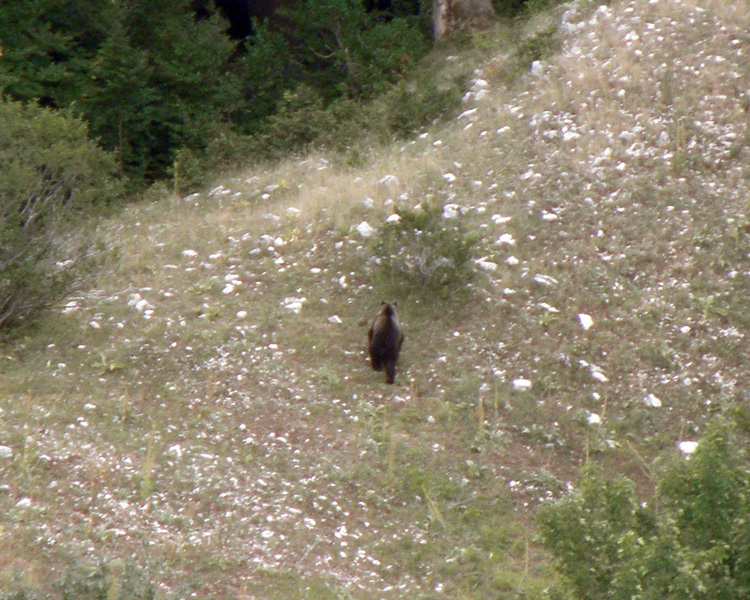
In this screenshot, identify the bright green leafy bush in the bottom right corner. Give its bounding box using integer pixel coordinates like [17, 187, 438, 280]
[539, 422, 750, 600]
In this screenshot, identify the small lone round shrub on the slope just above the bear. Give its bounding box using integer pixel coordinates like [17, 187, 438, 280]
[373, 205, 477, 295]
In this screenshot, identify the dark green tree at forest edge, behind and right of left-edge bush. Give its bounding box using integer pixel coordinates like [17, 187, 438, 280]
[81, 0, 240, 181]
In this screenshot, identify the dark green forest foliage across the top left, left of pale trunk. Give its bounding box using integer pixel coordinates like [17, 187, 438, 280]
[0, 0, 427, 185]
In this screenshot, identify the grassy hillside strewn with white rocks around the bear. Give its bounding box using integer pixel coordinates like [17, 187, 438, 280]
[0, 0, 750, 599]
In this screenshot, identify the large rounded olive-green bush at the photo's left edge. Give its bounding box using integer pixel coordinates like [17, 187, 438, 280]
[0, 101, 118, 328]
